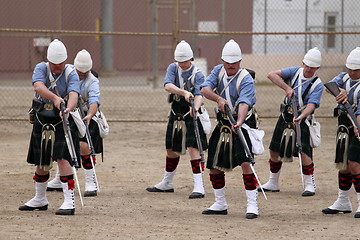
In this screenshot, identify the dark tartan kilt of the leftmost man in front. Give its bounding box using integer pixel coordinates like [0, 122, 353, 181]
[27, 115, 81, 166]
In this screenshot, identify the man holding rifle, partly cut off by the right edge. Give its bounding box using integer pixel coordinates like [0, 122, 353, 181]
[322, 47, 360, 218]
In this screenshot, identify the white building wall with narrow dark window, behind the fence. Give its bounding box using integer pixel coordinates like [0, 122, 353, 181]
[252, 0, 360, 54]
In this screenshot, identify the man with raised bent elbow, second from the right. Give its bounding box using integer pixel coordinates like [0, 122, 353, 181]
[259, 47, 324, 197]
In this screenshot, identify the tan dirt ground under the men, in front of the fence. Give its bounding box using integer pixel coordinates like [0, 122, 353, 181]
[0, 115, 360, 240]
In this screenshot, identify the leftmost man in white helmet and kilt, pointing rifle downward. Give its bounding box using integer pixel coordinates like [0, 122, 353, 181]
[19, 39, 80, 215]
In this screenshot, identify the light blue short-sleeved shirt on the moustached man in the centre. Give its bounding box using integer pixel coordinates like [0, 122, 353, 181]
[200, 64, 256, 108]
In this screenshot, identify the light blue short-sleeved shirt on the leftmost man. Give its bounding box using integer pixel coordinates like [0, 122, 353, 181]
[32, 62, 80, 102]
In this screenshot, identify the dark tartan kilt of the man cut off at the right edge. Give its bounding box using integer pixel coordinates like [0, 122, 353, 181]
[338, 112, 360, 163]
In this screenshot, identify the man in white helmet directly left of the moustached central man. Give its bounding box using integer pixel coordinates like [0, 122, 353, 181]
[146, 40, 207, 199]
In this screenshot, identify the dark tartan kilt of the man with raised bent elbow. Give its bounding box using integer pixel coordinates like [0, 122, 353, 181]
[269, 115, 313, 159]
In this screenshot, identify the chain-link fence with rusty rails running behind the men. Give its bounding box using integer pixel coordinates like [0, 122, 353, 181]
[0, 0, 360, 121]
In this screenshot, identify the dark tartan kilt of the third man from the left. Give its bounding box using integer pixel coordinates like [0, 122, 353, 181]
[165, 98, 208, 151]
